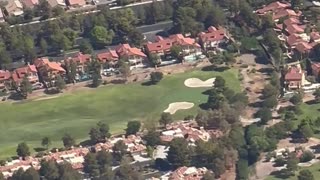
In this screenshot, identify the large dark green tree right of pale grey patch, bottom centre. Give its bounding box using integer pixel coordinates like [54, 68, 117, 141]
[167, 138, 191, 168]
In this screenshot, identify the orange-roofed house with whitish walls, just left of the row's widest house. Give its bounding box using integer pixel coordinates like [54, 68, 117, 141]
[116, 44, 147, 67]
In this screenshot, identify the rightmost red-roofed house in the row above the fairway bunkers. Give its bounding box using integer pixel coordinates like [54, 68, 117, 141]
[198, 26, 229, 51]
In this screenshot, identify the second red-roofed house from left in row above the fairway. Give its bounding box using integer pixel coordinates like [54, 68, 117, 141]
[12, 65, 39, 85]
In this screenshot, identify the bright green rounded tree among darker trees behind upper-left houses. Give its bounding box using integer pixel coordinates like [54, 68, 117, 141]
[90, 26, 114, 47]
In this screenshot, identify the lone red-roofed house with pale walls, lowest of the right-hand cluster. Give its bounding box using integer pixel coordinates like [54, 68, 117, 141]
[284, 66, 304, 90]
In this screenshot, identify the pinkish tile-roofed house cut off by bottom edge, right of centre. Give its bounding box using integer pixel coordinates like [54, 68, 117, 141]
[169, 166, 208, 180]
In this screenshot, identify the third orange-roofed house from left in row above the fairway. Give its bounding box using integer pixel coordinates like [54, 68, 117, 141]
[34, 58, 66, 86]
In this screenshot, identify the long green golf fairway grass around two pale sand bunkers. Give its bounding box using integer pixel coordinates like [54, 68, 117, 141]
[0, 69, 240, 158]
